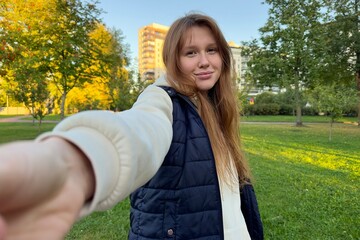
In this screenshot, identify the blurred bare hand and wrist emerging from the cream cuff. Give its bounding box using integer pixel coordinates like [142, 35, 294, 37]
[0, 137, 95, 240]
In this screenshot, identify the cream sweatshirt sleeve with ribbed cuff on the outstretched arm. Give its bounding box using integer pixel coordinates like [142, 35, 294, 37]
[37, 85, 172, 216]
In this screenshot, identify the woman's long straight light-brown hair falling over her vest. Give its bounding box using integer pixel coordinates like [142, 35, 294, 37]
[162, 13, 250, 184]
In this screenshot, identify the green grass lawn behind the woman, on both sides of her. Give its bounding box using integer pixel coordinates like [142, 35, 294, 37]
[0, 123, 360, 240]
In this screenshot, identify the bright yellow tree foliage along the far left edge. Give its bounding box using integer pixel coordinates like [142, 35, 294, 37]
[0, 0, 55, 120]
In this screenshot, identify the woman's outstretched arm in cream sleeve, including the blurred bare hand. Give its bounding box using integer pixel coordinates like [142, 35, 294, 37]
[0, 80, 172, 240]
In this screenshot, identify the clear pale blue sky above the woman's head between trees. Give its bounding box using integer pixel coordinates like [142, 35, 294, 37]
[98, 0, 268, 62]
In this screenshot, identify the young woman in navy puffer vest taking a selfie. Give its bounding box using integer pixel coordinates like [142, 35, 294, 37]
[0, 14, 263, 240]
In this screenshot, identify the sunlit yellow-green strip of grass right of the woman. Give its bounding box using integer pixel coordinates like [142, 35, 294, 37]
[243, 125, 360, 176]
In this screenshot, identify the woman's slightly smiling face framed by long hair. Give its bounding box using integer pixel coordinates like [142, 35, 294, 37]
[180, 26, 222, 91]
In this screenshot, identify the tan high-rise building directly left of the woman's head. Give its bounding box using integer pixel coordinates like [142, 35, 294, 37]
[138, 23, 169, 81]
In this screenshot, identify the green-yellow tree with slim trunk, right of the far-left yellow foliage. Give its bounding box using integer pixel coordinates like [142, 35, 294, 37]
[45, 0, 100, 118]
